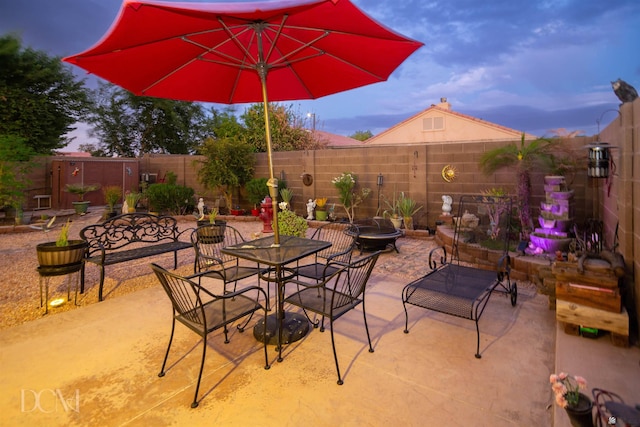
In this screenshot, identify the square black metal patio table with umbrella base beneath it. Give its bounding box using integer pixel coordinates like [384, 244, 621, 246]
[222, 236, 331, 362]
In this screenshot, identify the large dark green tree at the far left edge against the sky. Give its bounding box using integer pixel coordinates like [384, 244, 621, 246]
[0, 35, 91, 154]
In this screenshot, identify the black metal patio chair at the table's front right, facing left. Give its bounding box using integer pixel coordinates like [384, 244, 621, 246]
[284, 252, 380, 385]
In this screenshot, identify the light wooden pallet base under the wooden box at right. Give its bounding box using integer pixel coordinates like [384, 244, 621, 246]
[556, 299, 629, 347]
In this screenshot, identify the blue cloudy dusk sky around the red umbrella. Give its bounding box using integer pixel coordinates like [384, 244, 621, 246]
[0, 0, 640, 147]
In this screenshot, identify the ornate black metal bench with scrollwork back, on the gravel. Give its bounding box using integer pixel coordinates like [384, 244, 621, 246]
[80, 213, 193, 301]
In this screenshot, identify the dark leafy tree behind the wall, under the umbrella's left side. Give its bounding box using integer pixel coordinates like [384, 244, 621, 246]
[88, 83, 207, 157]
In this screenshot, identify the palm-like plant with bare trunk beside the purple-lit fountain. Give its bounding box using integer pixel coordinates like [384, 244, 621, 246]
[480, 133, 555, 240]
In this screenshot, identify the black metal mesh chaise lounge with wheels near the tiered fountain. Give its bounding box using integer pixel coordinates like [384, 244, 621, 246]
[402, 195, 518, 358]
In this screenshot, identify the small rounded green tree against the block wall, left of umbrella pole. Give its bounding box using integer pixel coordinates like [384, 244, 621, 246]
[198, 137, 255, 209]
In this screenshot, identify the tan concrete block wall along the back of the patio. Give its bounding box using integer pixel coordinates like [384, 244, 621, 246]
[141, 138, 593, 228]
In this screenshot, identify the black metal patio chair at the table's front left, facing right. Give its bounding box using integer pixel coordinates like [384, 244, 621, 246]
[151, 264, 270, 408]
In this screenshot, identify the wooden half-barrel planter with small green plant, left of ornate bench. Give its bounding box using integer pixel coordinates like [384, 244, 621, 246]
[36, 221, 87, 272]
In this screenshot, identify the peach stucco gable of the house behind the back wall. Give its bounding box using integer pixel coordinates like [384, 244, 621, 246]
[365, 98, 536, 144]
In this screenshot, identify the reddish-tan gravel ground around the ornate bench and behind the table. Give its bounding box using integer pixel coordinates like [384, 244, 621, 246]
[0, 211, 442, 330]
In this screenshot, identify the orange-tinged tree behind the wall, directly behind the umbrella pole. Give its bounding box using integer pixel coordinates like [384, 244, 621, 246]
[241, 104, 321, 152]
